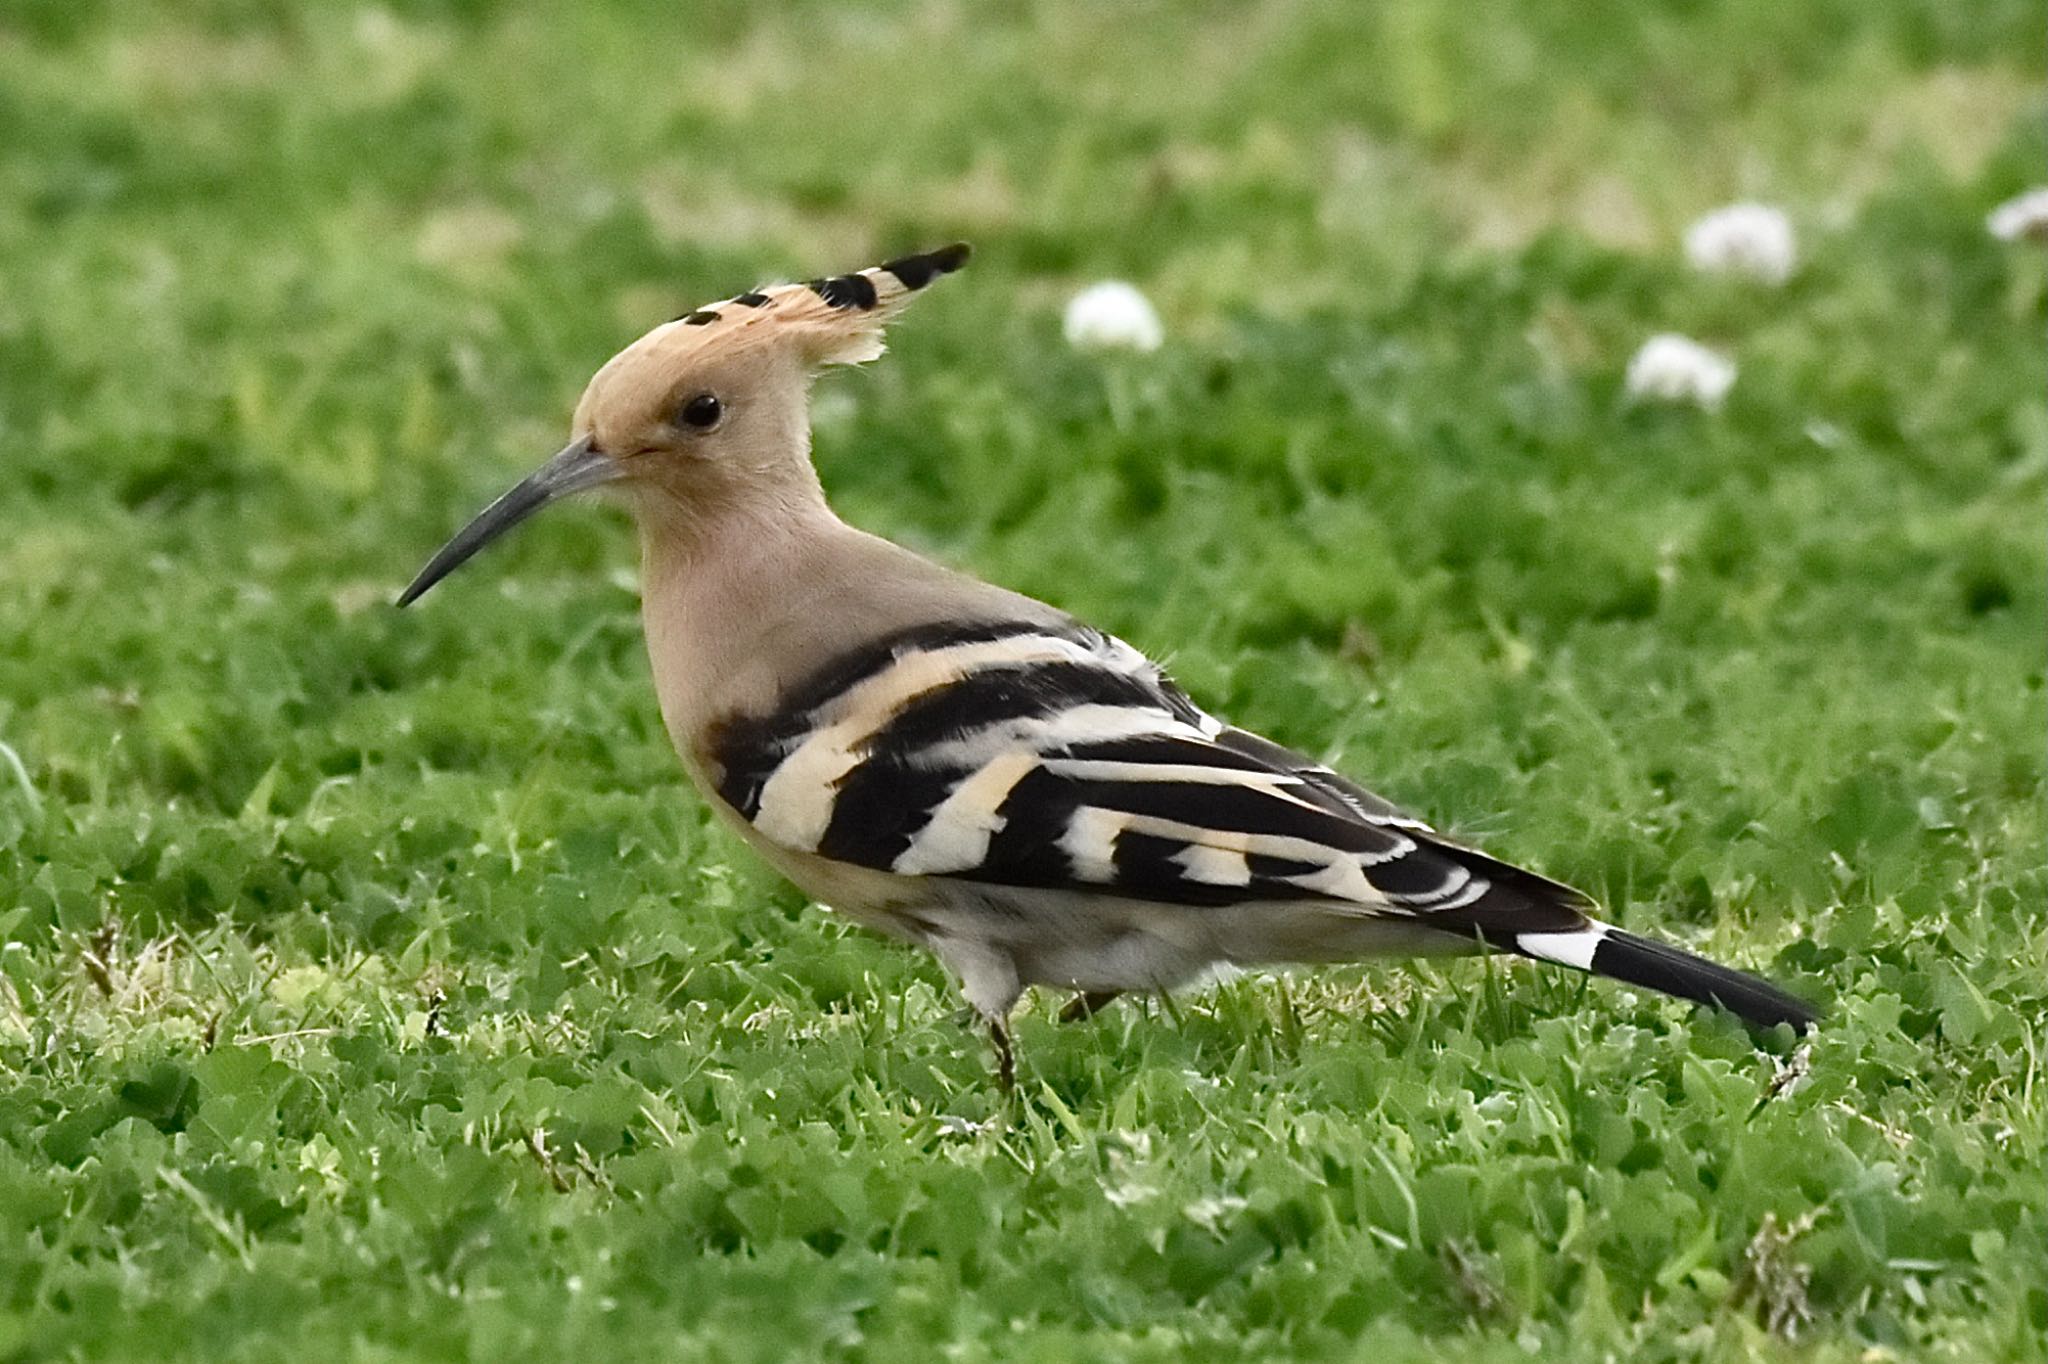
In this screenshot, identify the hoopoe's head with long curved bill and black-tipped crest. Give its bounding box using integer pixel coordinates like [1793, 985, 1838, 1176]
[397, 244, 967, 606]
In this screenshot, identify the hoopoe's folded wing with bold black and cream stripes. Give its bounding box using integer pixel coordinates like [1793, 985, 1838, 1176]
[705, 621, 1587, 933]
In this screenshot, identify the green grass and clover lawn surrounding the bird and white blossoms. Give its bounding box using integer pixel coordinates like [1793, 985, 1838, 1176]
[0, 0, 2048, 1364]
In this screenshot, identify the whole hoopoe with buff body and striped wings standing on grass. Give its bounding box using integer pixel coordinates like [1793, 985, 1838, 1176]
[397, 244, 1819, 1090]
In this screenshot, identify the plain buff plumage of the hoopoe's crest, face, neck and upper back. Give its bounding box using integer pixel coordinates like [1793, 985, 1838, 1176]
[544, 248, 1059, 745]
